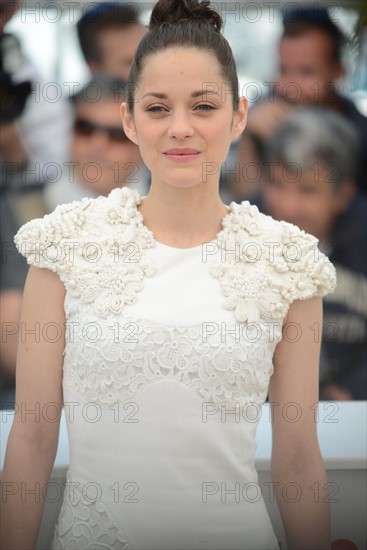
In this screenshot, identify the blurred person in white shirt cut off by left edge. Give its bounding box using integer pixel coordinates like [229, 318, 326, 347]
[0, 0, 70, 407]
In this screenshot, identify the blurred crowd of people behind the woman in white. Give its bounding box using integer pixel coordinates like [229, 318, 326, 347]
[0, 1, 367, 407]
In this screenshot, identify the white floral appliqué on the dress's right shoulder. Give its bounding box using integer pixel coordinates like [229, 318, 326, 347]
[210, 201, 336, 323]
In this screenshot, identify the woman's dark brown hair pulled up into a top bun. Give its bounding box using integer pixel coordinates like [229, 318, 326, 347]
[127, 0, 239, 113]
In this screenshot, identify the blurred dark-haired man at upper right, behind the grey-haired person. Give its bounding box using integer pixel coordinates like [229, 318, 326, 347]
[230, 6, 367, 201]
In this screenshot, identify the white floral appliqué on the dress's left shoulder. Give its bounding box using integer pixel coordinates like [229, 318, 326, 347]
[14, 188, 156, 317]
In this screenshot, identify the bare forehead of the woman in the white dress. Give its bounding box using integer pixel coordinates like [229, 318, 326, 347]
[139, 47, 224, 95]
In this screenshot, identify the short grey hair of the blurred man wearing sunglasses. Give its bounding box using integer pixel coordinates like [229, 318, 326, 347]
[70, 74, 127, 105]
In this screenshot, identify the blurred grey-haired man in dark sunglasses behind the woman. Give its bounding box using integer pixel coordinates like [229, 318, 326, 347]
[44, 75, 149, 212]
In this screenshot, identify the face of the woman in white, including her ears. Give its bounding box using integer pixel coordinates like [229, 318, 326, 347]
[121, 48, 247, 194]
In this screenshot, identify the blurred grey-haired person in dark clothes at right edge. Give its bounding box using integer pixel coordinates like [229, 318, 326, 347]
[259, 107, 367, 400]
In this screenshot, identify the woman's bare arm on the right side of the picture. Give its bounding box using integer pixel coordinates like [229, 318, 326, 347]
[269, 297, 331, 550]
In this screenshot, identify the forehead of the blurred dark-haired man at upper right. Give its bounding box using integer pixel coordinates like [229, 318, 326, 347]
[279, 29, 332, 65]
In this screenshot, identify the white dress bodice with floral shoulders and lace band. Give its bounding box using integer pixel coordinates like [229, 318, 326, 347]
[15, 188, 335, 408]
